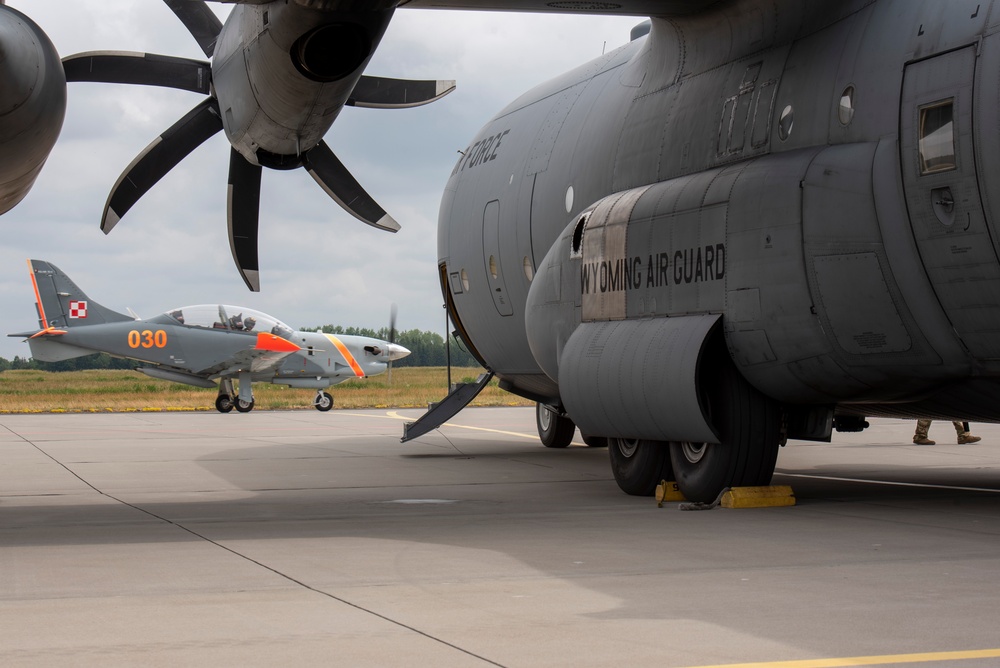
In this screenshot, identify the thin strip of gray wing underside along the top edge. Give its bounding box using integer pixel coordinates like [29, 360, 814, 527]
[398, 0, 723, 16]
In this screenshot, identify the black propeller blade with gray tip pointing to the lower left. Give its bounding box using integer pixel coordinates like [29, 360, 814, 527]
[101, 98, 222, 234]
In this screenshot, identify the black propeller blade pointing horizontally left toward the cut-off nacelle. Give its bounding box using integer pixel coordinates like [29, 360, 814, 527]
[63, 51, 212, 95]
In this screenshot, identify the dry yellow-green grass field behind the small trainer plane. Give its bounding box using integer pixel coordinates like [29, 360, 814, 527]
[0, 367, 533, 413]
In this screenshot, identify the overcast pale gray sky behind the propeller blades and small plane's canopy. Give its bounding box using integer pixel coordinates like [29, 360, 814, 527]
[0, 0, 639, 359]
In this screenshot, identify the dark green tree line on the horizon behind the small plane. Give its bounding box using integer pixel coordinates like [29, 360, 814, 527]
[0, 325, 479, 372]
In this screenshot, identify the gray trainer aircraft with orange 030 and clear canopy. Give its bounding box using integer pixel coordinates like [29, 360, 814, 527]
[9, 260, 410, 413]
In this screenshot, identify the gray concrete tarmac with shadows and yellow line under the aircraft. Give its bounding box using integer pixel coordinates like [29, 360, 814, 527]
[0, 408, 1000, 668]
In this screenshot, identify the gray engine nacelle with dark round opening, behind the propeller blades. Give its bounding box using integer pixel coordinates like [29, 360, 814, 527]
[212, 2, 393, 162]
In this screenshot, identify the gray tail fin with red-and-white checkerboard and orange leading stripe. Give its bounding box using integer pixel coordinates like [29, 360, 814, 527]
[28, 260, 132, 330]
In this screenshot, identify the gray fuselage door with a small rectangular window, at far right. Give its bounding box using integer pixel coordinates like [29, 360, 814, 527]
[900, 47, 1000, 359]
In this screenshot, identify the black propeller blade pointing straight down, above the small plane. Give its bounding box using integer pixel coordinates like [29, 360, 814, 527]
[226, 149, 262, 292]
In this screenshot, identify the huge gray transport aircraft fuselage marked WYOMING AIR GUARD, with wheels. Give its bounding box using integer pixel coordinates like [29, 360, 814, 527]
[439, 0, 1000, 499]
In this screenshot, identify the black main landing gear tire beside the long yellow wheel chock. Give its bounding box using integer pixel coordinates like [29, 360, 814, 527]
[670, 364, 781, 503]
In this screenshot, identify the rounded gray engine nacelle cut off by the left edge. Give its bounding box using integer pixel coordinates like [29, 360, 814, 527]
[0, 0, 66, 214]
